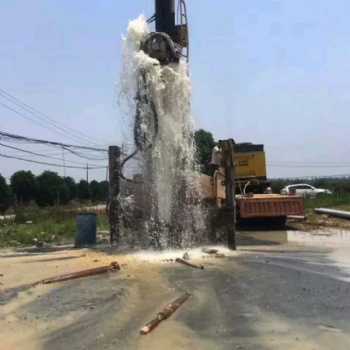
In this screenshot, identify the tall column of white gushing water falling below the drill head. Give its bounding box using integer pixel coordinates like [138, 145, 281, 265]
[121, 16, 205, 248]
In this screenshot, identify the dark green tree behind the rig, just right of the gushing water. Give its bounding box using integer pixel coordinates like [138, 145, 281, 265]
[194, 129, 216, 175]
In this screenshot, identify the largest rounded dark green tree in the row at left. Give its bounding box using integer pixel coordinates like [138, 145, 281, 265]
[35, 171, 69, 207]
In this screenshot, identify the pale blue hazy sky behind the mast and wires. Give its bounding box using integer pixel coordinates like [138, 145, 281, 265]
[0, 0, 350, 180]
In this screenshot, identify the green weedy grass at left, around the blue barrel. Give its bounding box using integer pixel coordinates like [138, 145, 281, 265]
[0, 207, 109, 247]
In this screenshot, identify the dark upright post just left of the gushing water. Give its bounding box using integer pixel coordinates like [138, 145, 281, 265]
[107, 146, 121, 244]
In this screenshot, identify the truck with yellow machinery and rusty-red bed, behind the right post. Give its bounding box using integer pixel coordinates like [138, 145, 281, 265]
[200, 143, 305, 225]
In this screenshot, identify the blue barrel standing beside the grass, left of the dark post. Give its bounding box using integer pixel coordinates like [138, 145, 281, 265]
[74, 213, 97, 247]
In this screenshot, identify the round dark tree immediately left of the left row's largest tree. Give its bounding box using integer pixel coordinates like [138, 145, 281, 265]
[10, 170, 36, 203]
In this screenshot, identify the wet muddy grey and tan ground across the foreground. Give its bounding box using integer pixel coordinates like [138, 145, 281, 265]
[0, 230, 350, 350]
